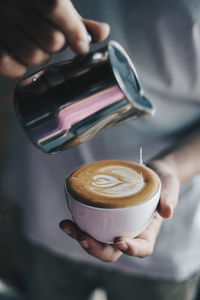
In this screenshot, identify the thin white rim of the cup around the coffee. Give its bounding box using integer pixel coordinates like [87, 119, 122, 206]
[64, 163, 161, 211]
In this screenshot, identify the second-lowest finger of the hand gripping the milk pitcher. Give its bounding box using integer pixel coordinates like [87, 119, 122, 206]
[0, 28, 50, 66]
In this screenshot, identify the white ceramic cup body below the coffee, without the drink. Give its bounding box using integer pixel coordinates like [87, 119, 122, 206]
[65, 168, 161, 244]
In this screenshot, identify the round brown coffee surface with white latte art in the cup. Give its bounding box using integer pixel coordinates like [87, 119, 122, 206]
[67, 160, 158, 208]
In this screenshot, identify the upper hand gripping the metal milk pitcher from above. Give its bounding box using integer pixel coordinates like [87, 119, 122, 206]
[0, 0, 109, 78]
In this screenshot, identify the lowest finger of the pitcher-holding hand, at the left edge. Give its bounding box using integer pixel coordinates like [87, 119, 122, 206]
[0, 47, 27, 78]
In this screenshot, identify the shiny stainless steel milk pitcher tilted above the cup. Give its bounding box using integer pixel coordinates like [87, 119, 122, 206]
[14, 41, 155, 153]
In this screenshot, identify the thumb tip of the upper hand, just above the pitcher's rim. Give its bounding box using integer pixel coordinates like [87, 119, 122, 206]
[83, 19, 110, 43]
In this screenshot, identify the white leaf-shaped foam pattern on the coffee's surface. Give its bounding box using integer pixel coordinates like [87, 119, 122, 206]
[88, 166, 144, 197]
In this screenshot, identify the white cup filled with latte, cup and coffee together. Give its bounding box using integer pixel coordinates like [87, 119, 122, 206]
[65, 160, 161, 243]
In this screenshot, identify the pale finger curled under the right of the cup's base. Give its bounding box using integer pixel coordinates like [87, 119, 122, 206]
[114, 213, 163, 258]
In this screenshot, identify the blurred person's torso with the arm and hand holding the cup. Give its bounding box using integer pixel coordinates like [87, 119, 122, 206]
[1, 0, 200, 300]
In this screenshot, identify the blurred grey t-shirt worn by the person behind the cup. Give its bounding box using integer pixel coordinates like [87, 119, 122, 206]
[1, 0, 200, 280]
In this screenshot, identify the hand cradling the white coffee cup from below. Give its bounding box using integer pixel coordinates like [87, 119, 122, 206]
[60, 160, 180, 262]
